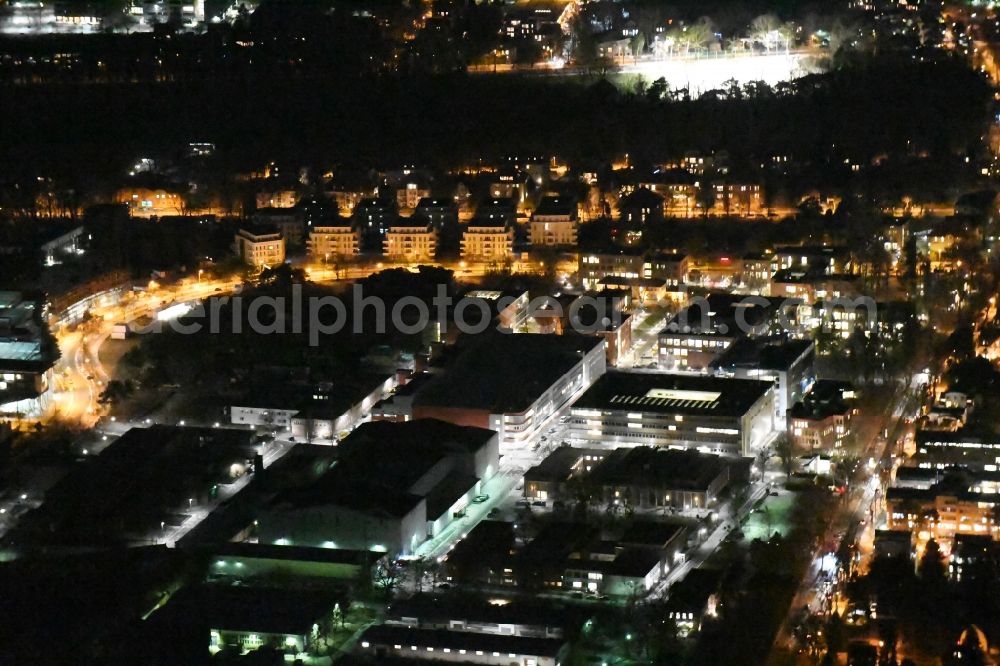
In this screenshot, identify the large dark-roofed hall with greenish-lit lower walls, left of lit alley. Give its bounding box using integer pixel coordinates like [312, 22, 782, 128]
[258, 419, 500, 556]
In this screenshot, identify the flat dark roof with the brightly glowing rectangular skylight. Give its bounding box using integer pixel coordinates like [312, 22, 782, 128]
[573, 372, 773, 417]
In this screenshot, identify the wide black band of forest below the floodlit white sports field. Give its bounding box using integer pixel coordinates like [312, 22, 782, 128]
[0, 52, 989, 184]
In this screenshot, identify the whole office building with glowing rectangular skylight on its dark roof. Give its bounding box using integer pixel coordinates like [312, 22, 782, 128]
[570, 372, 775, 456]
